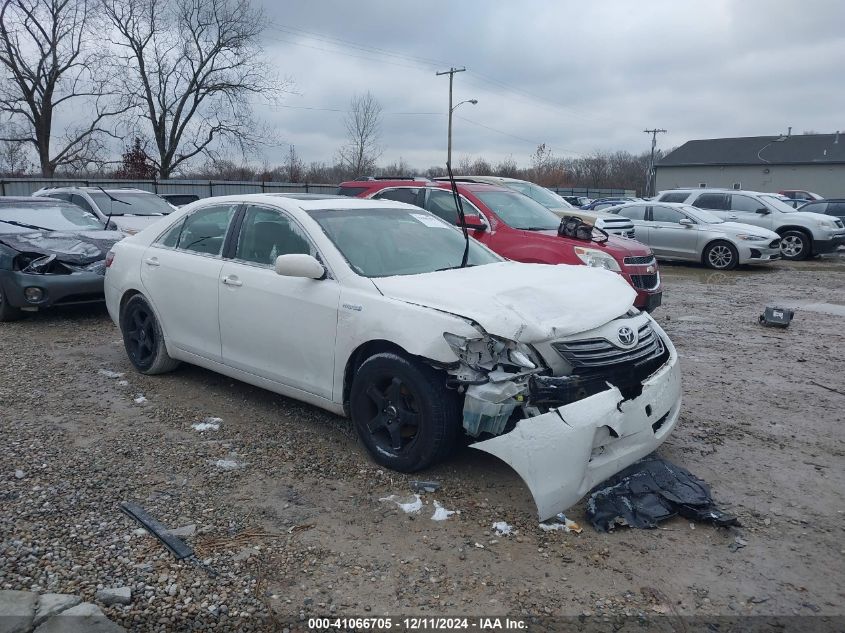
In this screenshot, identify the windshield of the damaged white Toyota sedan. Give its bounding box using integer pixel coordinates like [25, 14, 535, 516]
[308, 208, 502, 277]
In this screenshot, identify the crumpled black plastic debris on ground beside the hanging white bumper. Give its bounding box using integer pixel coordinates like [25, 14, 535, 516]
[587, 454, 739, 532]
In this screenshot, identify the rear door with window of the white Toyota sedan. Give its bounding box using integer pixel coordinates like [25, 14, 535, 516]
[141, 204, 238, 362]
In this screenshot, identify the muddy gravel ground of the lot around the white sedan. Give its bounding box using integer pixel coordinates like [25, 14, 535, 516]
[0, 255, 845, 630]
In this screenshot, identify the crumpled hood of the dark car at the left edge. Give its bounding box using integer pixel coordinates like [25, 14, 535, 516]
[0, 228, 124, 266]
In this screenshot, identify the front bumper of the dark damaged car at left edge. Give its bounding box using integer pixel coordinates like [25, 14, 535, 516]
[0, 270, 104, 310]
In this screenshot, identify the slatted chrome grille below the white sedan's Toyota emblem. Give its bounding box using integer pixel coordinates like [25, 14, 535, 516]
[552, 323, 663, 373]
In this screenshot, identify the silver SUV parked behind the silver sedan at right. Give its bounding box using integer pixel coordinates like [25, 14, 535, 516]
[657, 189, 845, 260]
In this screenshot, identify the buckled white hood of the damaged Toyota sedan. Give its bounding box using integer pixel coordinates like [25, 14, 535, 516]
[372, 262, 636, 343]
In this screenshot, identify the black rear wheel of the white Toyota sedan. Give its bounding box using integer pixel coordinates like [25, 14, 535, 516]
[120, 295, 179, 375]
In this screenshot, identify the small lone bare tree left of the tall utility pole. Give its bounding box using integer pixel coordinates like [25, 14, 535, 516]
[338, 92, 384, 178]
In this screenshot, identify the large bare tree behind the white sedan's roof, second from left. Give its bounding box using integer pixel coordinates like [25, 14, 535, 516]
[101, 0, 290, 178]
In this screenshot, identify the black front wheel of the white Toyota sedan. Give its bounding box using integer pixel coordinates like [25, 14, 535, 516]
[349, 353, 461, 472]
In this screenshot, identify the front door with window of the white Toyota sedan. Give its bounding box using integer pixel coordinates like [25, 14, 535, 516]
[217, 205, 340, 398]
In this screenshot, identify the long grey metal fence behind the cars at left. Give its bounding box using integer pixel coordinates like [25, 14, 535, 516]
[0, 178, 337, 198]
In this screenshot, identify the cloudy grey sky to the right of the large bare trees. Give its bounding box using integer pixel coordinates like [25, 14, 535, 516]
[254, 0, 845, 168]
